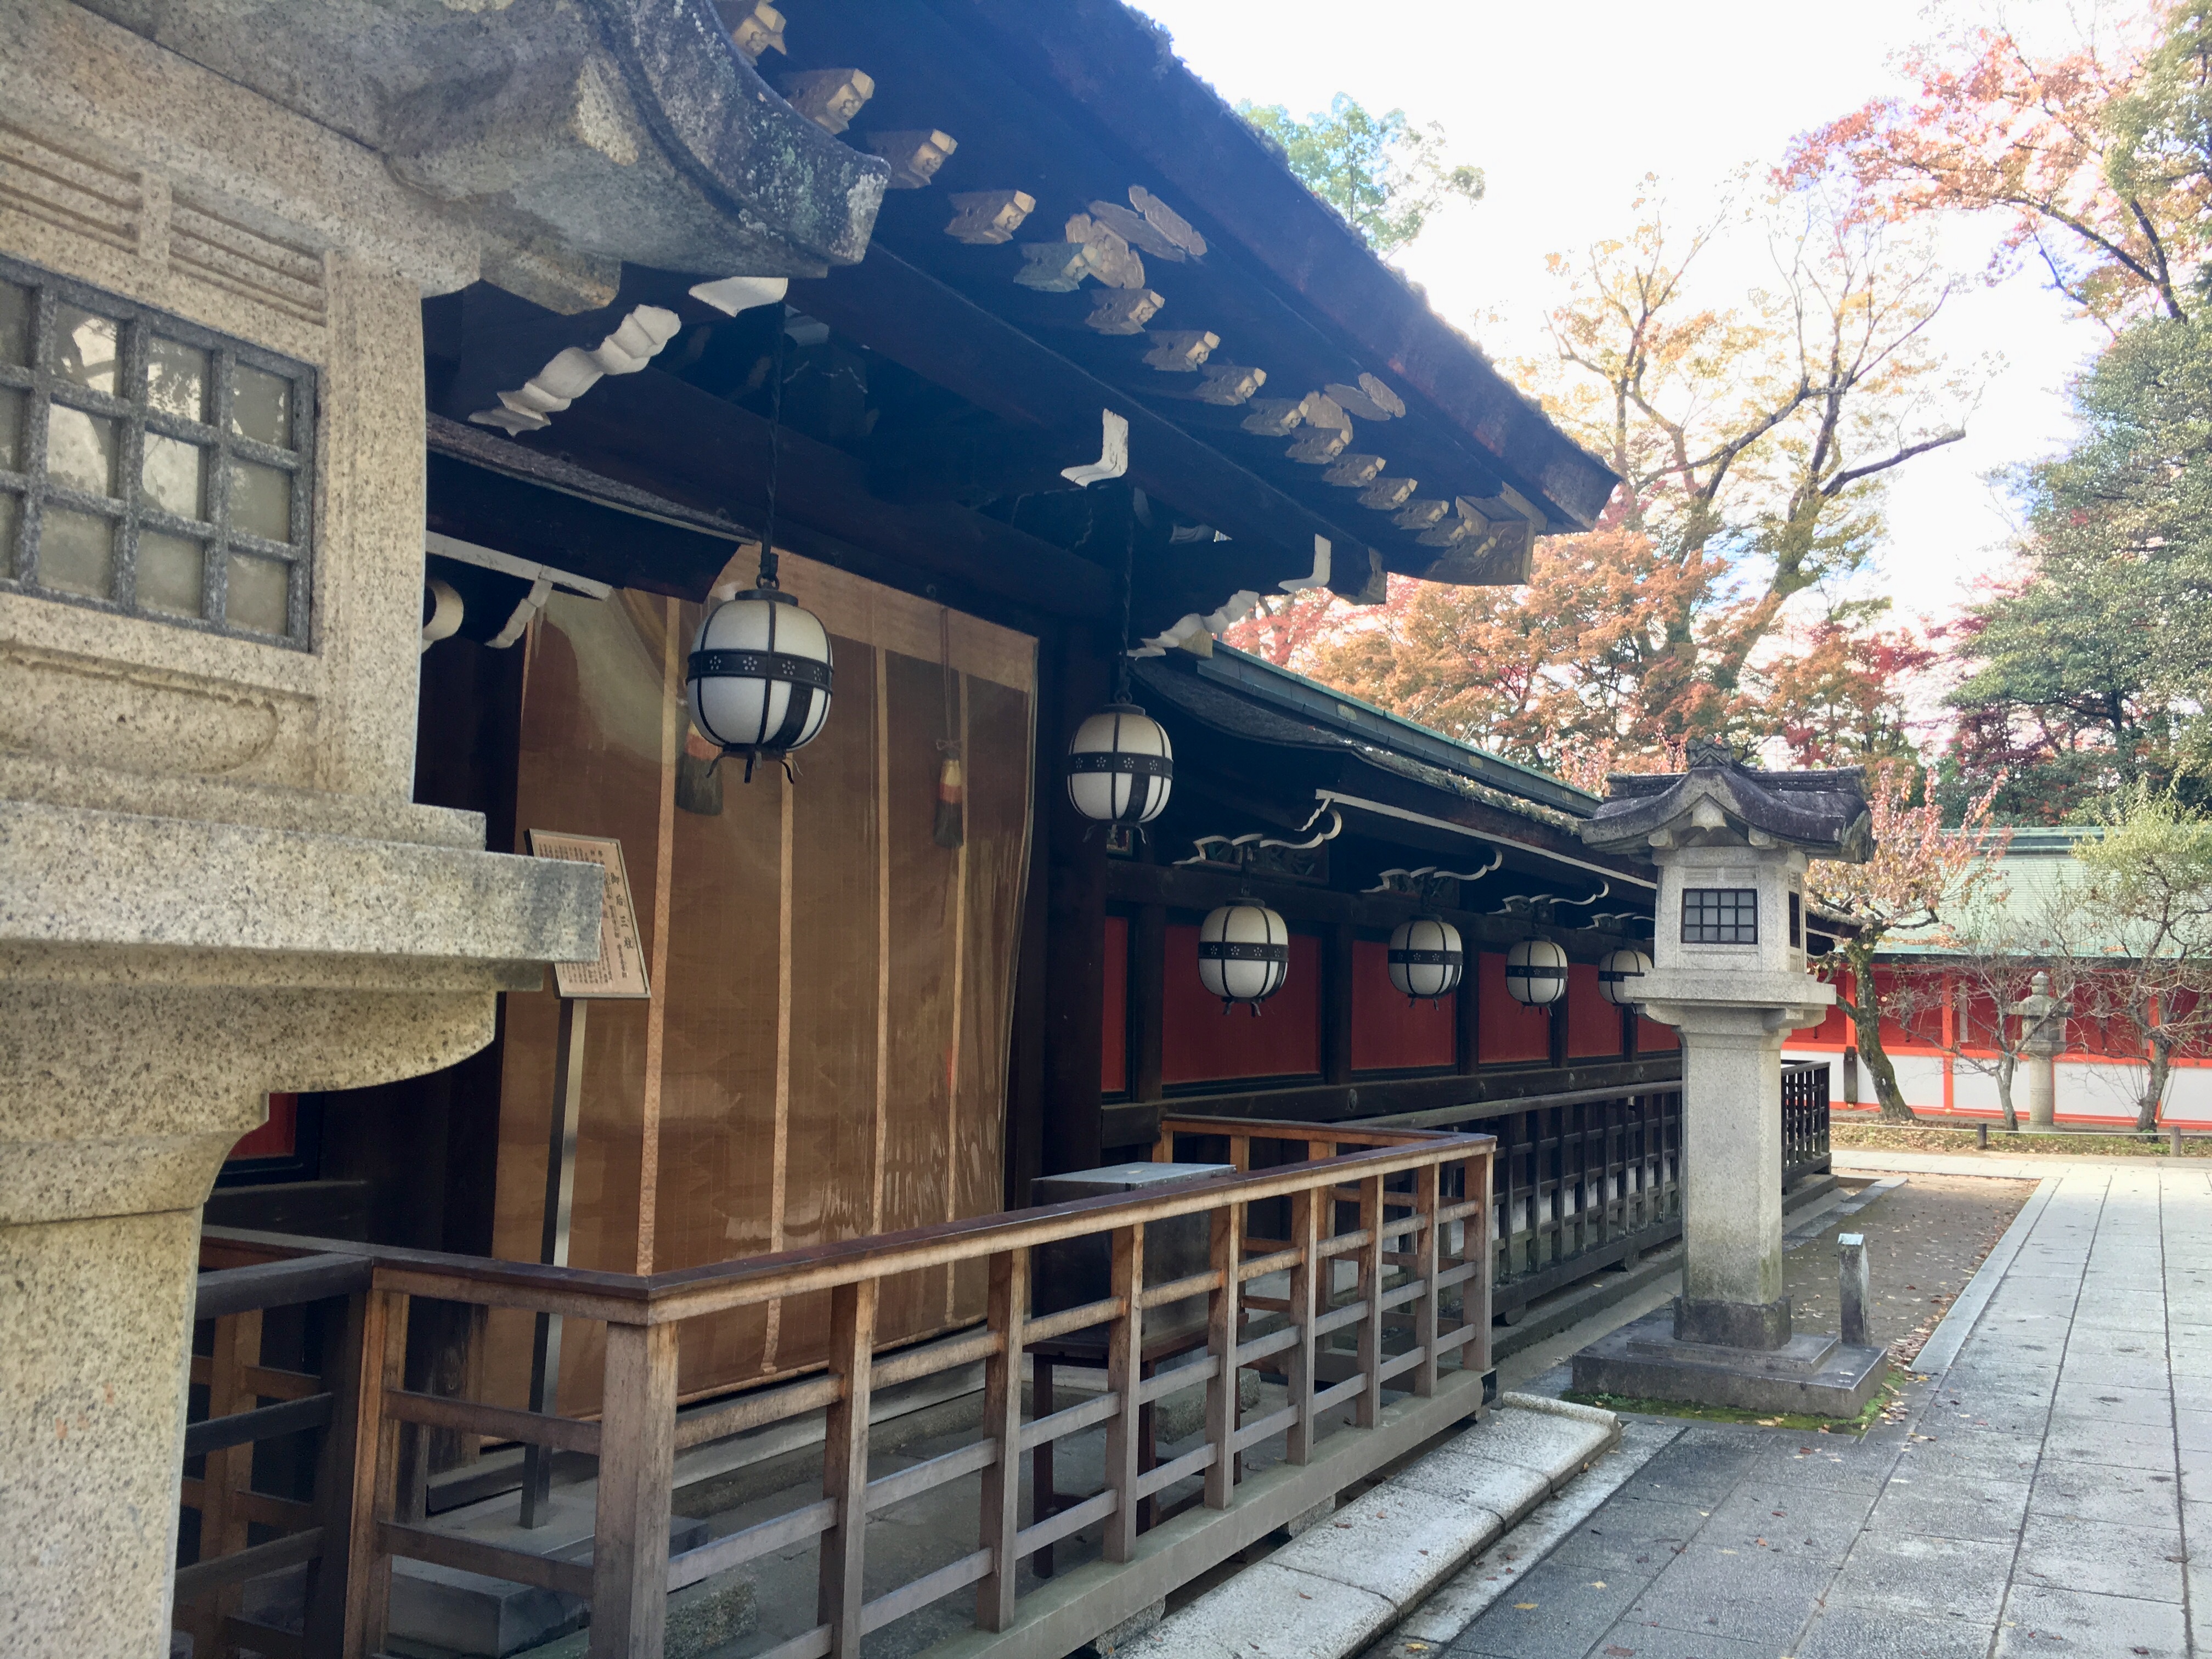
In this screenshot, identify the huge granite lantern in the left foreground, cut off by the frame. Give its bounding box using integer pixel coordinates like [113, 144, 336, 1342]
[0, 0, 887, 1659]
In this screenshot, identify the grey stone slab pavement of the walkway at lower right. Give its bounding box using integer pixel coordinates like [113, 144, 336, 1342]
[1442, 1159, 2212, 1659]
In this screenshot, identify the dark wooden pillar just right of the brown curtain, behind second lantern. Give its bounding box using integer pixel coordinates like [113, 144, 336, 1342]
[1037, 628, 1113, 1175]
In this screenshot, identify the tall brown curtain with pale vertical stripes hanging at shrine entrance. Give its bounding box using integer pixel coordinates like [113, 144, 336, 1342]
[491, 549, 1035, 1411]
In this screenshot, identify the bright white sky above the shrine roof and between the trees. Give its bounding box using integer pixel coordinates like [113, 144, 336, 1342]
[1137, 0, 2103, 637]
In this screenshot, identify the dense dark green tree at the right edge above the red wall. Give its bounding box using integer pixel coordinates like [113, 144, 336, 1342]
[1949, 317, 2212, 821]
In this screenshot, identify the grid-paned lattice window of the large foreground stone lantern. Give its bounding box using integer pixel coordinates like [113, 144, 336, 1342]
[0, 259, 314, 648]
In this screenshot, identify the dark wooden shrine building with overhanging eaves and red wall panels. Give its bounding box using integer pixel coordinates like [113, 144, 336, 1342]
[181, 4, 1674, 1404]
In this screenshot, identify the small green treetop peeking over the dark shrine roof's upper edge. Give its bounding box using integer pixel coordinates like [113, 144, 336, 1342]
[1237, 93, 1482, 255]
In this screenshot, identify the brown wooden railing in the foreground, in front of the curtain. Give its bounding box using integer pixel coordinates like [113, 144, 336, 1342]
[190, 1119, 1493, 1659]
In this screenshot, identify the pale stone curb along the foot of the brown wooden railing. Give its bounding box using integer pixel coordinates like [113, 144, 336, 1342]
[1115, 1393, 1621, 1659]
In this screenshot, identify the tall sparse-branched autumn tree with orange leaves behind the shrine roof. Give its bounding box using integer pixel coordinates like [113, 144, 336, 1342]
[1230, 186, 1964, 770]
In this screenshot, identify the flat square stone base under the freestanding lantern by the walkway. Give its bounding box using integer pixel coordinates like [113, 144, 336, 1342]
[1575, 1307, 1889, 1418]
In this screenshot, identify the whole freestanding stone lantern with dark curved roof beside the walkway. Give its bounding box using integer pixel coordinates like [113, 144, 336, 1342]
[1575, 746, 1880, 1415]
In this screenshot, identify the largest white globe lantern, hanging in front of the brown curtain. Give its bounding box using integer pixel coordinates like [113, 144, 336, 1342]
[686, 586, 834, 783]
